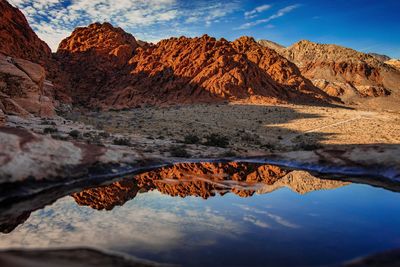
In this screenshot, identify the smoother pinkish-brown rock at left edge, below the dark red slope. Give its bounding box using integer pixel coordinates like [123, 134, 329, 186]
[0, 54, 55, 117]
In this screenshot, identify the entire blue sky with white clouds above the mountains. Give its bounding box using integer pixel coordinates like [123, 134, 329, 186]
[10, 0, 400, 58]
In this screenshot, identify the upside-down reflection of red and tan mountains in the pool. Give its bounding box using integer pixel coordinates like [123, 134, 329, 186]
[72, 162, 348, 210]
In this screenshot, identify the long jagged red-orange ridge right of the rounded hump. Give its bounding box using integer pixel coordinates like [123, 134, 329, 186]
[100, 35, 332, 107]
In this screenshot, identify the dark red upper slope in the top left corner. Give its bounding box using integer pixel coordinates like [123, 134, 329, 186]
[0, 0, 51, 65]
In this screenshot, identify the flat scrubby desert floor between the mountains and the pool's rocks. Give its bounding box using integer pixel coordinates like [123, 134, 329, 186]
[8, 104, 400, 157]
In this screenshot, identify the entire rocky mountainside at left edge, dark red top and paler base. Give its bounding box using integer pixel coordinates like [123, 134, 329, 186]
[0, 0, 54, 118]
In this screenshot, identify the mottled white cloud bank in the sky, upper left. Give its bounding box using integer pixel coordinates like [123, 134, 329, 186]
[11, 0, 239, 51]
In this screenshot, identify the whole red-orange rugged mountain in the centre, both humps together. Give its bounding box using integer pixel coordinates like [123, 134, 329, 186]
[57, 23, 327, 108]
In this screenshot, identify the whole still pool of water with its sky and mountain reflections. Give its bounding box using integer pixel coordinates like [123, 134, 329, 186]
[0, 162, 400, 266]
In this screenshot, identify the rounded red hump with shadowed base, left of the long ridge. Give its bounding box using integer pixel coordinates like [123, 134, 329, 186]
[55, 23, 139, 105]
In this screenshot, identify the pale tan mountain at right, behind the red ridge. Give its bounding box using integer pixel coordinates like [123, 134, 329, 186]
[259, 40, 400, 100]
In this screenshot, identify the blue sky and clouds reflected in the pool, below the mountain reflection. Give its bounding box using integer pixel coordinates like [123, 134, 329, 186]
[0, 185, 400, 265]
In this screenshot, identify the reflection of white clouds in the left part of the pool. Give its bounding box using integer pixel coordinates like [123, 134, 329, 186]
[0, 192, 243, 250]
